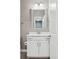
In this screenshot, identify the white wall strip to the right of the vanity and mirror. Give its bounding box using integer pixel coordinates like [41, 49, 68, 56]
[49, 0, 58, 59]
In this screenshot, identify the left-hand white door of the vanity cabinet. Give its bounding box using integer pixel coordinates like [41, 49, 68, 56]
[27, 40, 38, 57]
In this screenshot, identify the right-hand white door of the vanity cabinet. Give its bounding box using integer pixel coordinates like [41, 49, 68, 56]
[39, 41, 50, 57]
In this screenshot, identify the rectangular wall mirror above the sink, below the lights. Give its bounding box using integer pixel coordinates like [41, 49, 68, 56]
[31, 9, 46, 30]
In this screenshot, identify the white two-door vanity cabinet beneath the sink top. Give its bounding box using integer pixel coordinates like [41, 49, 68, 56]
[27, 33, 50, 57]
